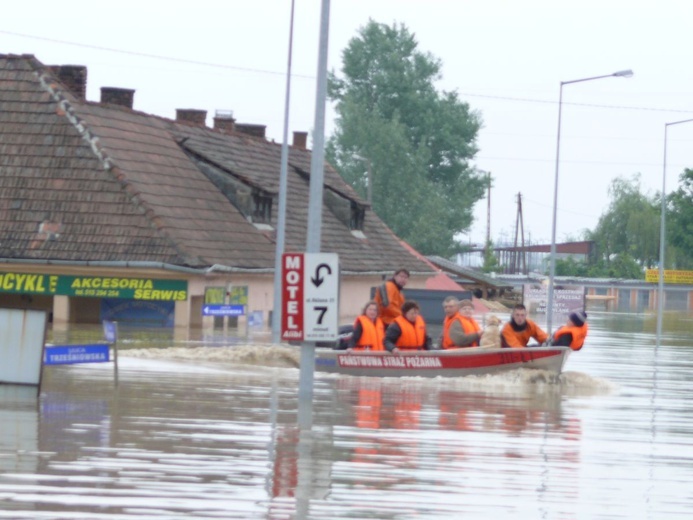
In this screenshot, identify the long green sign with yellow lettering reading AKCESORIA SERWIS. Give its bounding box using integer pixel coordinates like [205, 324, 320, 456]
[0, 273, 188, 301]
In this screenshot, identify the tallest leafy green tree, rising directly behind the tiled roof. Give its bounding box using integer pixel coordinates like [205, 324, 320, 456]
[326, 20, 485, 257]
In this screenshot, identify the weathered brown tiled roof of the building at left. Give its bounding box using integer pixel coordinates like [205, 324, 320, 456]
[0, 55, 431, 272]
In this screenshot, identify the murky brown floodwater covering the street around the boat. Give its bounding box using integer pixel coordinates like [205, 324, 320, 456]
[0, 313, 693, 520]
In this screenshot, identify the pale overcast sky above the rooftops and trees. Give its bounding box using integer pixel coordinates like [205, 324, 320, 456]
[5, 0, 693, 248]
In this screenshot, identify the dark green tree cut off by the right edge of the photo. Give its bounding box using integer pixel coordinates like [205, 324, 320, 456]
[665, 168, 693, 269]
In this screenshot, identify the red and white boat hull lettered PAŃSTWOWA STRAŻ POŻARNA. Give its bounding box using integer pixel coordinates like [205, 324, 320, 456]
[315, 347, 571, 377]
